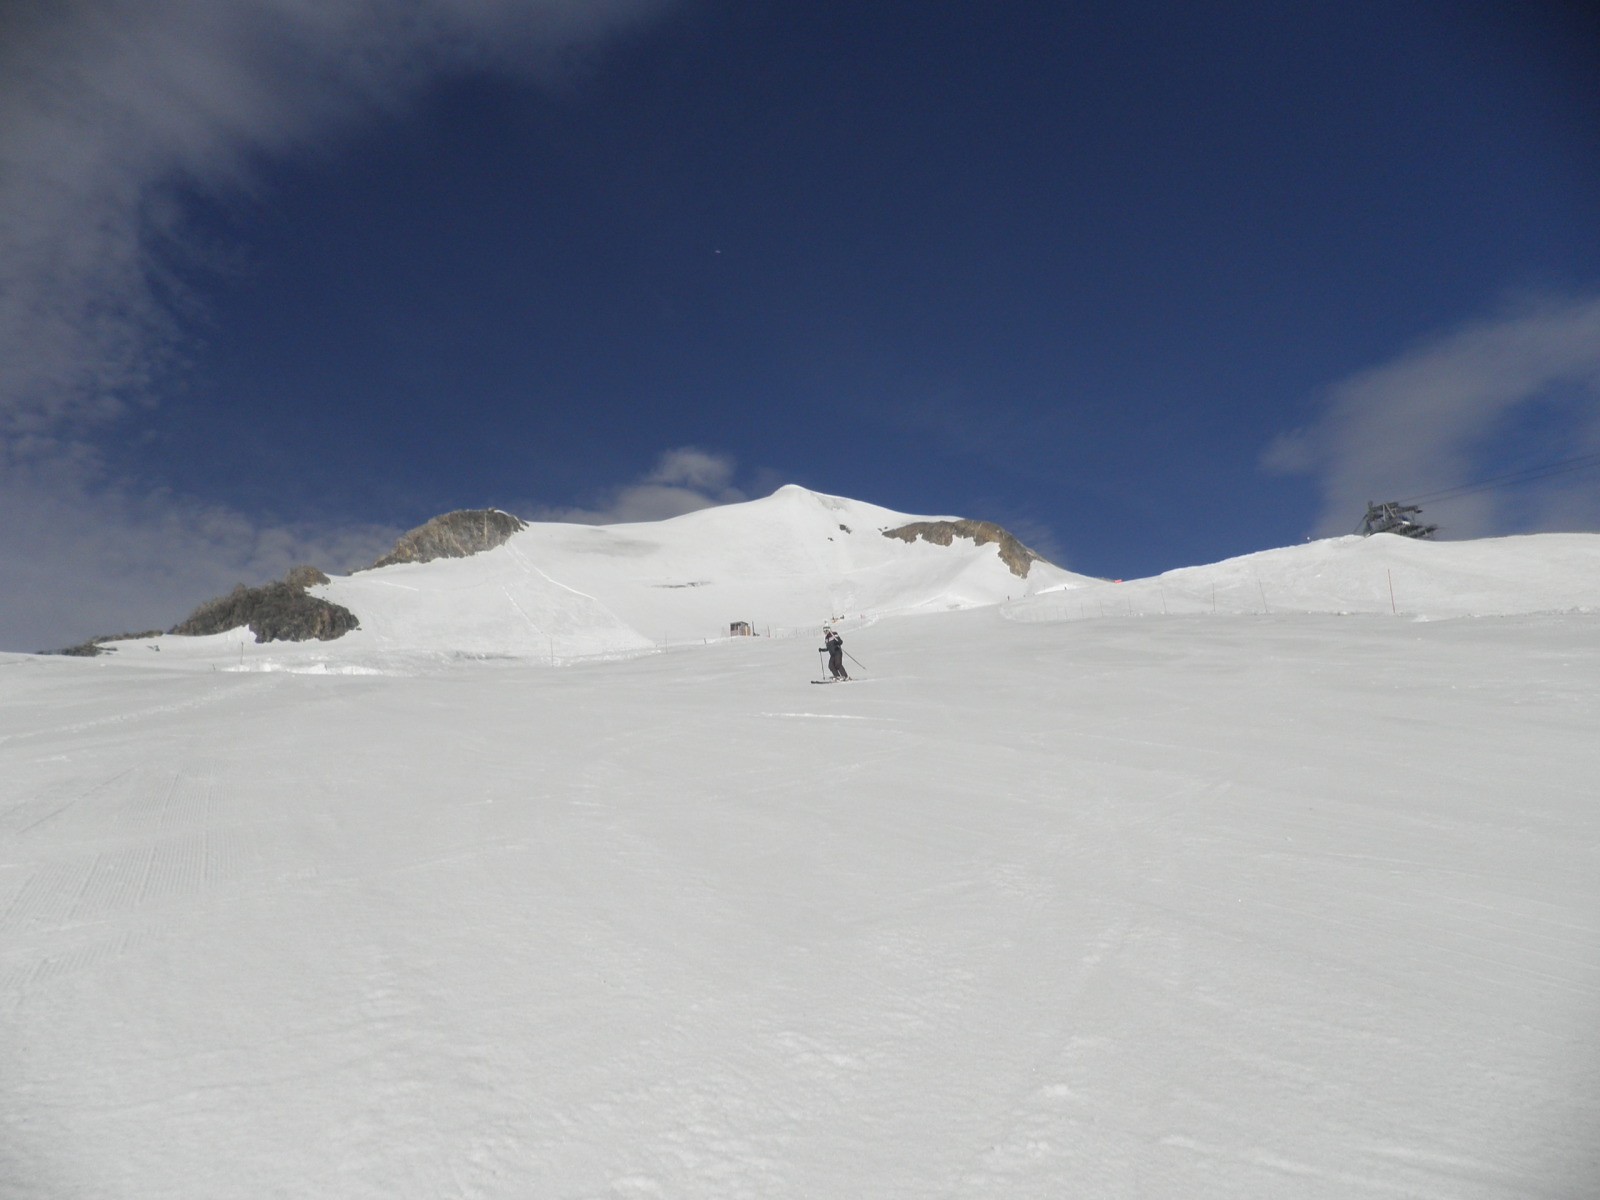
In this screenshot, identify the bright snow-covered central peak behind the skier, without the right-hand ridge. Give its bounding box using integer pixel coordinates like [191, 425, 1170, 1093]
[193, 485, 1093, 659]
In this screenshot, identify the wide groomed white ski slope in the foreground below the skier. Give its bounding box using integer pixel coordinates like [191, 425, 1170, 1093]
[9, 528, 1600, 1200]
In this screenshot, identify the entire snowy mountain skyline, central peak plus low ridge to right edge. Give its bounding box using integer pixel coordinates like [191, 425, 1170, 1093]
[78, 485, 1600, 670]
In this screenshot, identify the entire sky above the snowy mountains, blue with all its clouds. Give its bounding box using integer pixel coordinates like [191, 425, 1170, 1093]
[0, 0, 1600, 650]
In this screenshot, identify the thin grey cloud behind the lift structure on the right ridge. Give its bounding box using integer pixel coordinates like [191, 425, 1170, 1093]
[1262, 296, 1600, 536]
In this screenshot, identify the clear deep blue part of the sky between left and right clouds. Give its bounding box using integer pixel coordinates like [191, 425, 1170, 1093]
[122, 0, 1600, 578]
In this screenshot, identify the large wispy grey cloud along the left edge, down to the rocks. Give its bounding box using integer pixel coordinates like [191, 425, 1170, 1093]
[0, 0, 670, 659]
